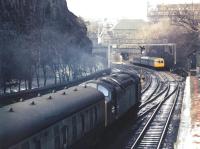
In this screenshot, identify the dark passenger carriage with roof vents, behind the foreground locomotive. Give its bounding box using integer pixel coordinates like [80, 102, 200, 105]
[0, 87, 105, 149]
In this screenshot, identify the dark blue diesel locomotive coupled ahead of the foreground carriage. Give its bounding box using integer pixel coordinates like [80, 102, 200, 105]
[82, 72, 141, 127]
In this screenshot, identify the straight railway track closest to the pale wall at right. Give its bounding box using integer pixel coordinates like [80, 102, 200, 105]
[126, 84, 180, 149]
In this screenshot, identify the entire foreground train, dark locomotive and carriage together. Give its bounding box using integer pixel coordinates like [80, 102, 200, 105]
[0, 71, 141, 149]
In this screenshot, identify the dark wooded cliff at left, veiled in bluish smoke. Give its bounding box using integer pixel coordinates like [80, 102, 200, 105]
[0, 0, 92, 92]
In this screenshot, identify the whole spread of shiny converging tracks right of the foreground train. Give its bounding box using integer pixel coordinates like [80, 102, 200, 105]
[97, 65, 182, 149]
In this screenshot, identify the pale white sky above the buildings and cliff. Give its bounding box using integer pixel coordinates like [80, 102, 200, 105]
[67, 0, 200, 19]
